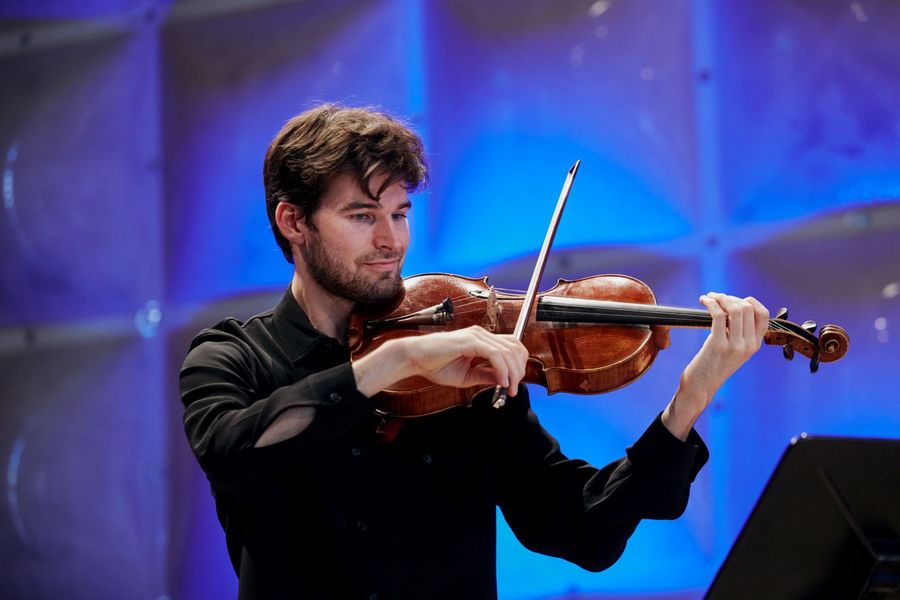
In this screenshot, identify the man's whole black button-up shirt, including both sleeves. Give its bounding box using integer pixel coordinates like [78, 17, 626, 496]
[181, 290, 709, 599]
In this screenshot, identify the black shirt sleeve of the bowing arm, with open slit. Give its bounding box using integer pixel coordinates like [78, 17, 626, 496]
[180, 332, 374, 493]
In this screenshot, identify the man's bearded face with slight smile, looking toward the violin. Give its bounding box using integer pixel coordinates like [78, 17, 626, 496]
[299, 175, 411, 303]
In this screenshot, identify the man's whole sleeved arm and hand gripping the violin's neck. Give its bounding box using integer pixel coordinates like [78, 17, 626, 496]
[498, 293, 769, 571]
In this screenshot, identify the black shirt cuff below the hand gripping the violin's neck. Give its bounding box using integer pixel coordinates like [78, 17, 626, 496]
[626, 413, 709, 485]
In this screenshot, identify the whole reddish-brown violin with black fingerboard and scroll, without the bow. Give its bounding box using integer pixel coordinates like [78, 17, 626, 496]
[348, 273, 850, 418]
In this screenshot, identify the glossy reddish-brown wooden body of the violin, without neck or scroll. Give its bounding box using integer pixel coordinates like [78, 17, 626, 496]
[348, 274, 668, 417]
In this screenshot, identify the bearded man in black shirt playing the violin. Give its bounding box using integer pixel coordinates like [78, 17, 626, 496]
[181, 105, 768, 599]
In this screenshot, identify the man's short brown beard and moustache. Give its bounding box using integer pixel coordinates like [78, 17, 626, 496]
[300, 234, 403, 304]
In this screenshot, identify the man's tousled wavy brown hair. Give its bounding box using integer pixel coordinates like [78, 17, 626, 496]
[263, 104, 428, 263]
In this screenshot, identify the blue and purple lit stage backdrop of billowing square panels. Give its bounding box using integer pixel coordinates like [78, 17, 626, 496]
[0, 0, 900, 600]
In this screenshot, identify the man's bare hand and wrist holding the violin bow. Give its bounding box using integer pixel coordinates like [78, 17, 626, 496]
[353, 326, 528, 396]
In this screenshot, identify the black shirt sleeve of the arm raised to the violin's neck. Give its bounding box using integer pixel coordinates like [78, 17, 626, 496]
[498, 390, 709, 571]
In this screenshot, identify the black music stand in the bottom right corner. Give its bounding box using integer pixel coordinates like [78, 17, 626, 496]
[705, 434, 900, 600]
